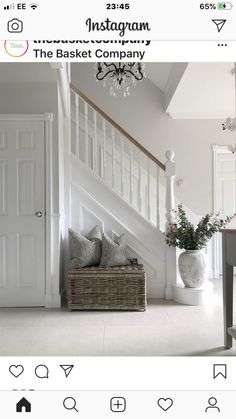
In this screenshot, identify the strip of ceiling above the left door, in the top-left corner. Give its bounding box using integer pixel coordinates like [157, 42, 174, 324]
[0, 63, 57, 84]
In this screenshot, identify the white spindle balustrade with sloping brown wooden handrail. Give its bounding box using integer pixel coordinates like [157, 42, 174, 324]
[71, 85, 168, 228]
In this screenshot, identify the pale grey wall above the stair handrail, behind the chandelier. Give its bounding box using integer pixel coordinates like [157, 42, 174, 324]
[72, 63, 235, 220]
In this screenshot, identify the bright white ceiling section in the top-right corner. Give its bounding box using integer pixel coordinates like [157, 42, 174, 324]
[167, 63, 235, 119]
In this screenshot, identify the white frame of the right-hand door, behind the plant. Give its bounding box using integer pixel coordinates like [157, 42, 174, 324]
[212, 145, 231, 278]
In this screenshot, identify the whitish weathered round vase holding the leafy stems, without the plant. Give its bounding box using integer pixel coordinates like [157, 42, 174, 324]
[178, 250, 208, 288]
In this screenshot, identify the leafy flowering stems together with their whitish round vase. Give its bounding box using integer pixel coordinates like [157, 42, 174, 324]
[165, 204, 235, 288]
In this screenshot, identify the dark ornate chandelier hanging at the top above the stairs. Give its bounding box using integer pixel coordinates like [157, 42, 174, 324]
[95, 63, 146, 97]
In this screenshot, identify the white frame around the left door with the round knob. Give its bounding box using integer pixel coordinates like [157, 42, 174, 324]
[0, 113, 61, 308]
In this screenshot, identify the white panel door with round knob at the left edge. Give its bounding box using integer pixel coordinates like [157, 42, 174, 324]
[0, 120, 45, 307]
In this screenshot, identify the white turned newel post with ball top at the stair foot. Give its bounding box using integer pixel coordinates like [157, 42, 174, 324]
[165, 150, 177, 300]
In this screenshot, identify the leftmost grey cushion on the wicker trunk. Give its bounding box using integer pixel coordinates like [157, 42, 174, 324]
[69, 226, 102, 268]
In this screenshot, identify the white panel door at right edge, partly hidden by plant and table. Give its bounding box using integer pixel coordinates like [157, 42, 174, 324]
[216, 151, 236, 275]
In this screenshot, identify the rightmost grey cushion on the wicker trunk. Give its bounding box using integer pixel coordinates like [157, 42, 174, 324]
[100, 233, 128, 266]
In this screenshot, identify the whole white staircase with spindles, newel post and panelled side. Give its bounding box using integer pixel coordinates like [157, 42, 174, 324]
[71, 85, 176, 298]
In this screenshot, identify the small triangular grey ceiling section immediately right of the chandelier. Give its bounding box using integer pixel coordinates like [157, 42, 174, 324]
[145, 63, 174, 91]
